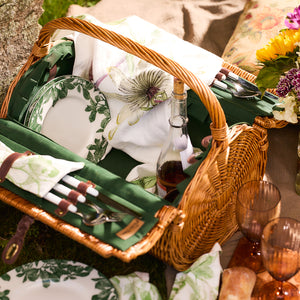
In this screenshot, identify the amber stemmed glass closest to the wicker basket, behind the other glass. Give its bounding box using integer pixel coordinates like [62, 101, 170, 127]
[236, 180, 281, 273]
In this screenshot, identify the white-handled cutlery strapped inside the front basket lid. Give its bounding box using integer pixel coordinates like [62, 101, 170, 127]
[44, 175, 142, 226]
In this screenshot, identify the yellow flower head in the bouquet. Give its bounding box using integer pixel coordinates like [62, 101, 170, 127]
[256, 29, 300, 62]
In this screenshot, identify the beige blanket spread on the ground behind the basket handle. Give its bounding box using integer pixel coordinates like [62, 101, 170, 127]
[68, 0, 246, 56]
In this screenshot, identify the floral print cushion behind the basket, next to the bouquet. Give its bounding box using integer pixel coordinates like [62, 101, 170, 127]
[222, 0, 299, 75]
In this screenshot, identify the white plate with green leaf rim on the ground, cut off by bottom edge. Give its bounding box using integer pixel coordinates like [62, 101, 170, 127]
[0, 259, 118, 300]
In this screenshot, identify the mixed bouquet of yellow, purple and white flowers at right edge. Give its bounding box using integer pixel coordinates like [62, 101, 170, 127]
[256, 6, 300, 123]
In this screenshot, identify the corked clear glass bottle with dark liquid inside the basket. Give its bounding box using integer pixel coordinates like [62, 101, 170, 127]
[156, 78, 193, 202]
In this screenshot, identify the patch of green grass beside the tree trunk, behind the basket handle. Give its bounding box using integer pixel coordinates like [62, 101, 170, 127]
[39, 0, 100, 26]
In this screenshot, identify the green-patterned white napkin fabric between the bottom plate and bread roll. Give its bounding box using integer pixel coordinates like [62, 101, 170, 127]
[110, 243, 222, 300]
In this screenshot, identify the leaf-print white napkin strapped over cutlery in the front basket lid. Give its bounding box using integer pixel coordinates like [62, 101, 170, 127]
[0, 141, 84, 198]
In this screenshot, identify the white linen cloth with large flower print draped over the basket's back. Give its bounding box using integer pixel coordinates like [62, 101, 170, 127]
[58, 15, 223, 164]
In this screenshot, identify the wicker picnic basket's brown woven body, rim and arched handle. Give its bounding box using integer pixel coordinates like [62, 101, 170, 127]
[0, 18, 285, 271]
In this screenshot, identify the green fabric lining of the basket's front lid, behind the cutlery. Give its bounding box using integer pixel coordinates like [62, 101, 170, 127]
[0, 119, 170, 251]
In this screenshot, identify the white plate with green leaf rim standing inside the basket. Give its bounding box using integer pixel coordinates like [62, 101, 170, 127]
[25, 76, 111, 163]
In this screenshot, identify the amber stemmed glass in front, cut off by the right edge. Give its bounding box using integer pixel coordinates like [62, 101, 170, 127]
[259, 218, 300, 300]
